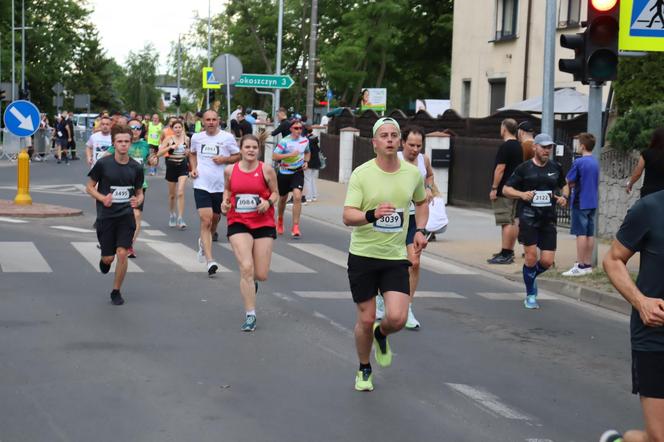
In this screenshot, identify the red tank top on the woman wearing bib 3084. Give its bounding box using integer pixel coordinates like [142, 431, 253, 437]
[227, 161, 275, 230]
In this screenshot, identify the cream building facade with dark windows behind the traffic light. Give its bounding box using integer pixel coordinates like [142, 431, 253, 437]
[450, 0, 608, 117]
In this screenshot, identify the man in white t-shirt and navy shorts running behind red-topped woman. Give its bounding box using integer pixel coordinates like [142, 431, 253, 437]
[189, 109, 240, 276]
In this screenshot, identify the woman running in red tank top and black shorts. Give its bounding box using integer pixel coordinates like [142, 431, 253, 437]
[221, 135, 279, 332]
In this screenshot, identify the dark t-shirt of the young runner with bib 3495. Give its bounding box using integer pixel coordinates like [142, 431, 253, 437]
[88, 155, 143, 219]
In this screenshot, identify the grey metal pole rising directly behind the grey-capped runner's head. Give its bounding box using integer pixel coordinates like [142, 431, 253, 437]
[542, 0, 556, 137]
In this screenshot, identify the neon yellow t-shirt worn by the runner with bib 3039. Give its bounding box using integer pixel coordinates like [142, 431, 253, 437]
[344, 160, 426, 260]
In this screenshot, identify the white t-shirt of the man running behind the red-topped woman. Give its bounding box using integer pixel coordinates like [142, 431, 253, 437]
[191, 130, 240, 193]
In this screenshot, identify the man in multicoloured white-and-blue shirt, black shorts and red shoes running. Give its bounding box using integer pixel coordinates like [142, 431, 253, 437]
[272, 120, 311, 238]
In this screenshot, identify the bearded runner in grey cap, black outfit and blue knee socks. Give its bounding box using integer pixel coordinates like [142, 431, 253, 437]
[503, 134, 569, 309]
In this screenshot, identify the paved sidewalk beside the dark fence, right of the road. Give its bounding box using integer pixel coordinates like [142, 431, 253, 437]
[302, 180, 639, 313]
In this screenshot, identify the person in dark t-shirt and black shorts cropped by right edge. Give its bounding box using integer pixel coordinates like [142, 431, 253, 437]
[603, 189, 664, 442]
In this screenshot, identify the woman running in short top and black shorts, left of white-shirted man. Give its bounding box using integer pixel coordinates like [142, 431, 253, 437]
[157, 120, 189, 230]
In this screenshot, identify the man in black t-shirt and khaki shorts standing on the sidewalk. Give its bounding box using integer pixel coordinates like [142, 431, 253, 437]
[487, 118, 523, 264]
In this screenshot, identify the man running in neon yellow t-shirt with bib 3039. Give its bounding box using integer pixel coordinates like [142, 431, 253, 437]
[343, 118, 429, 391]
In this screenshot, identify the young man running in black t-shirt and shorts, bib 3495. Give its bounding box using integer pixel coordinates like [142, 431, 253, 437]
[86, 125, 143, 305]
